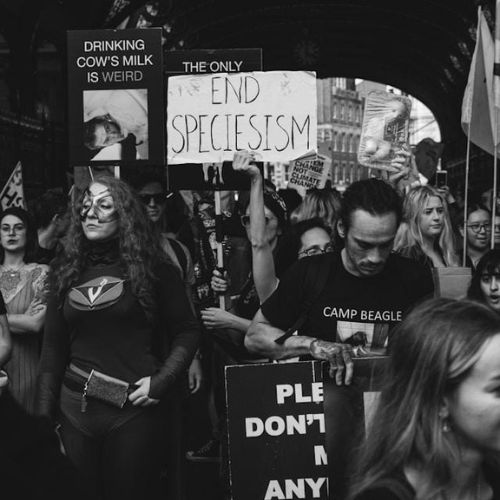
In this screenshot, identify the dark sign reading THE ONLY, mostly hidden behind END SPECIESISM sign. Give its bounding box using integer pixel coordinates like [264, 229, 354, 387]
[165, 49, 262, 76]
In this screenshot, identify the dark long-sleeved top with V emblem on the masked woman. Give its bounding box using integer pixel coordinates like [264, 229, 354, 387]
[37, 263, 200, 415]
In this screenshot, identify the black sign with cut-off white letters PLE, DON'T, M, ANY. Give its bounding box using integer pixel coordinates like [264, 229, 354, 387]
[226, 362, 328, 500]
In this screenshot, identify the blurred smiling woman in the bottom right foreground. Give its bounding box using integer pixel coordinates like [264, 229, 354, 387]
[349, 299, 500, 500]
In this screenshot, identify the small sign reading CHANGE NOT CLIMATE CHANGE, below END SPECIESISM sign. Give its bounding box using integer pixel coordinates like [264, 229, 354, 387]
[287, 153, 332, 194]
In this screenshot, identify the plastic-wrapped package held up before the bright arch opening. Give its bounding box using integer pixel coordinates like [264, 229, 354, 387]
[358, 90, 411, 172]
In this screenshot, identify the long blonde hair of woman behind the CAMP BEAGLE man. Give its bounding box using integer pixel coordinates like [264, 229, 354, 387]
[394, 186, 460, 267]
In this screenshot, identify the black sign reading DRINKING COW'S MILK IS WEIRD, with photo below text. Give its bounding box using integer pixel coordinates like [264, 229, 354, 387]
[68, 28, 165, 167]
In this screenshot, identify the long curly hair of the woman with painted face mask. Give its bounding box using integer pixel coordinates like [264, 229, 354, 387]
[50, 176, 166, 322]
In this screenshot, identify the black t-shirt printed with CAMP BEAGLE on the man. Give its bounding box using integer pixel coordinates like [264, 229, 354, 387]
[262, 252, 434, 347]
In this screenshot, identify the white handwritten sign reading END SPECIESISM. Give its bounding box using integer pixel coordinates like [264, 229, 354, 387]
[167, 71, 317, 164]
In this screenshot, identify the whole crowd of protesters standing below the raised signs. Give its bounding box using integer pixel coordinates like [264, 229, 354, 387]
[0, 151, 500, 500]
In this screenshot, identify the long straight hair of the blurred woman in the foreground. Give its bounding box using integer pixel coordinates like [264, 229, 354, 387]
[349, 299, 500, 500]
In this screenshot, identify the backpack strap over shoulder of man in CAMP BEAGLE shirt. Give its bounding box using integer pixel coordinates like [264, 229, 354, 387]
[275, 254, 337, 345]
